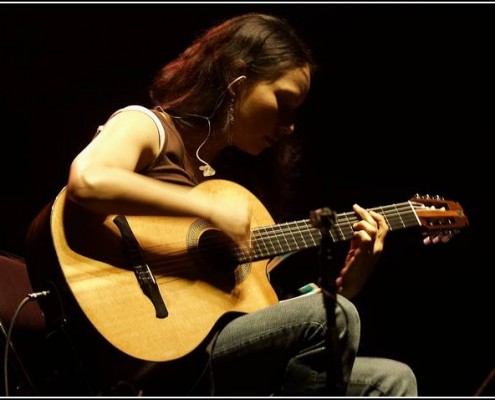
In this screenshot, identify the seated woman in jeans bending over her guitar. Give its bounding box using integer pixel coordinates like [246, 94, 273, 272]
[33, 13, 416, 395]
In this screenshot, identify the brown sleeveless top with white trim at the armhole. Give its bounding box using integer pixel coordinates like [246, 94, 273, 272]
[101, 106, 198, 186]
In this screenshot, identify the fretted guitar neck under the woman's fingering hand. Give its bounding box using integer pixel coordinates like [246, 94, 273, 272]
[238, 201, 421, 263]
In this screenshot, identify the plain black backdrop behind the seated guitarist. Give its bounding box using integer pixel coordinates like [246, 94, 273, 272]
[0, 3, 495, 396]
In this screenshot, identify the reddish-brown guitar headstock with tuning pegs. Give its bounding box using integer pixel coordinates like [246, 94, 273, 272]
[410, 195, 469, 244]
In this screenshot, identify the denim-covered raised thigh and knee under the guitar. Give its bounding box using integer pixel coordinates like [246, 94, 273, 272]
[212, 294, 359, 395]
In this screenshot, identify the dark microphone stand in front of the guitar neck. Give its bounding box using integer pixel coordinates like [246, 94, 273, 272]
[310, 208, 346, 396]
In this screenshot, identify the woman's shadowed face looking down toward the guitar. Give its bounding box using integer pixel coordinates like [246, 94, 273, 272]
[231, 66, 310, 155]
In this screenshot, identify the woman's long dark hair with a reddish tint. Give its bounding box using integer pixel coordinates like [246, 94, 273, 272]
[149, 13, 314, 129]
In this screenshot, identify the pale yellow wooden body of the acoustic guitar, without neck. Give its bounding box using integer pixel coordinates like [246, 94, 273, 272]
[29, 180, 278, 361]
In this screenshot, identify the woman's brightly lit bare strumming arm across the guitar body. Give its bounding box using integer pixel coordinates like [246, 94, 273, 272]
[67, 111, 250, 247]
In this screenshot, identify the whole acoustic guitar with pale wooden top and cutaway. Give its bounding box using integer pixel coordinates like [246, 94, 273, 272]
[28, 180, 468, 361]
